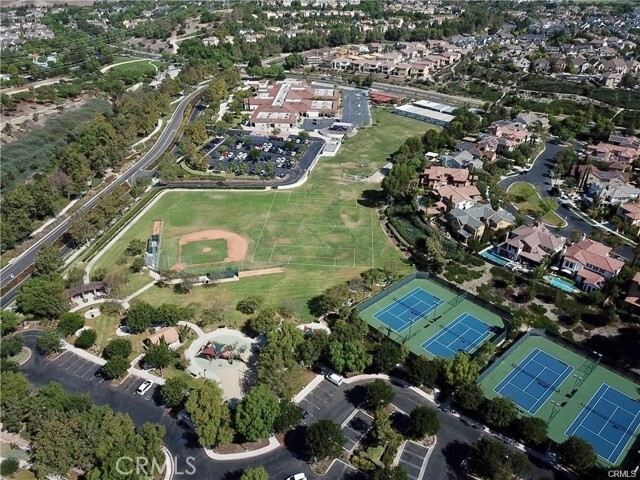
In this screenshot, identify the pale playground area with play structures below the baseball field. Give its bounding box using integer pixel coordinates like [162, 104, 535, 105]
[185, 328, 257, 400]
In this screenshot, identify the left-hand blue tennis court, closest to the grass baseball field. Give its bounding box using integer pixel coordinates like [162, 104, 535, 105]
[373, 288, 444, 333]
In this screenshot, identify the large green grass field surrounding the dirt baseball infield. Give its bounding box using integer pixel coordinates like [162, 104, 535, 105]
[84, 109, 424, 325]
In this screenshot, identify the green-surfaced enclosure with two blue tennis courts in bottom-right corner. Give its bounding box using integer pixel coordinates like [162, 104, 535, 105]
[478, 334, 640, 465]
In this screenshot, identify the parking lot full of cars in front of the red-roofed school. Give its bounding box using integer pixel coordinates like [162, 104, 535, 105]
[204, 133, 312, 178]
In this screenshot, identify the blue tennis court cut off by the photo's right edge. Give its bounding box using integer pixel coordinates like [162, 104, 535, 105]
[565, 383, 640, 465]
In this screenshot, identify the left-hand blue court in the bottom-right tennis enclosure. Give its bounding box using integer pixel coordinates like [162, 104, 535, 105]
[493, 348, 573, 414]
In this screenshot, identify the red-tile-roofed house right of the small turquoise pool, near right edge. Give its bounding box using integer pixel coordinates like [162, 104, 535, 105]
[560, 238, 624, 292]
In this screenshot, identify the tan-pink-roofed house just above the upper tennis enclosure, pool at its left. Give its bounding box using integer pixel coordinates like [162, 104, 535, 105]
[496, 223, 566, 264]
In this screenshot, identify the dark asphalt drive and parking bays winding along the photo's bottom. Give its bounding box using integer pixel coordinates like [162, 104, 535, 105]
[20, 331, 565, 480]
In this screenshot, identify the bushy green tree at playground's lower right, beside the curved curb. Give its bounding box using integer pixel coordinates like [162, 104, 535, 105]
[235, 385, 279, 442]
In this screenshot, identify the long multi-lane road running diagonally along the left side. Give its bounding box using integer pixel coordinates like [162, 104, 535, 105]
[0, 85, 207, 308]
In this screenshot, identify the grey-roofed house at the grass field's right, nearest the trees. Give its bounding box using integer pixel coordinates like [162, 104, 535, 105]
[447, 203, 515, 243]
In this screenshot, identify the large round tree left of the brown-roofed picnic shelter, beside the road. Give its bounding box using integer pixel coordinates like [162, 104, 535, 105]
[16, 275, 69, 318]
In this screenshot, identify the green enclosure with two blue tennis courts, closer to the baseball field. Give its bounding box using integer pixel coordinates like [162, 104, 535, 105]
[358, 276, 505, 358]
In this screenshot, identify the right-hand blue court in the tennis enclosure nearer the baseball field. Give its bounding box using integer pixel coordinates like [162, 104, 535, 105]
[422, 313, 491, 358]
